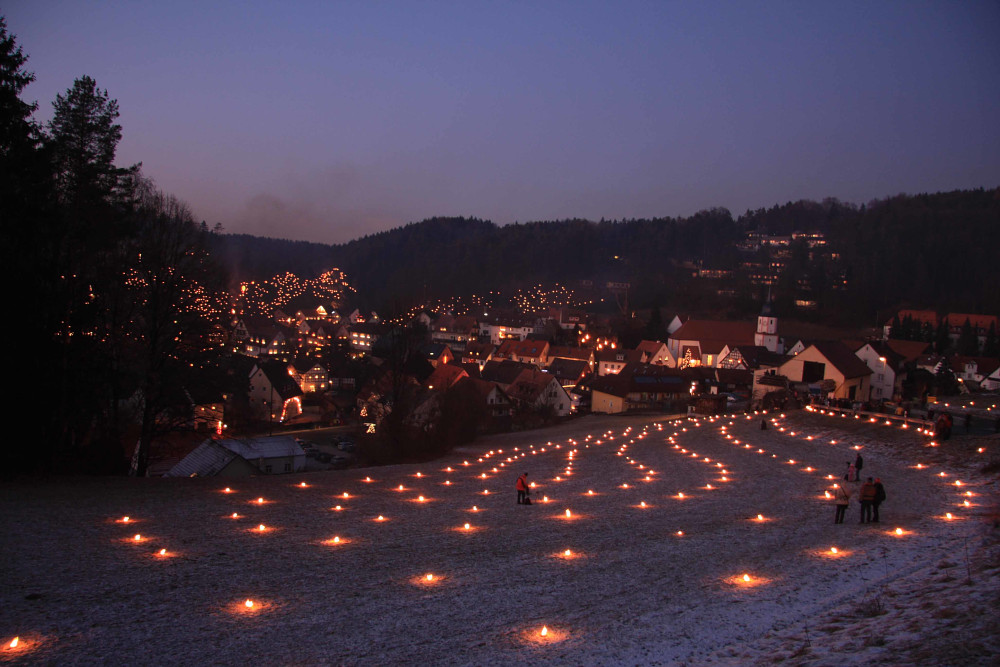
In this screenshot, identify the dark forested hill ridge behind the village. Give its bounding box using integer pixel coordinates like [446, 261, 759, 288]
[218, 189, 1000, 322]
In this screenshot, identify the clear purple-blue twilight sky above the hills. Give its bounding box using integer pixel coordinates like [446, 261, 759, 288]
[0, 0, 1000, 243]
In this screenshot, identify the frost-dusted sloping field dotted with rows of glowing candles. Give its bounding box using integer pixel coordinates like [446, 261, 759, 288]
[0, 412, 1000, 665]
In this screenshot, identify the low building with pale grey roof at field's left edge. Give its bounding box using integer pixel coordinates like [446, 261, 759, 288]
[164, 435, 306, 477]
